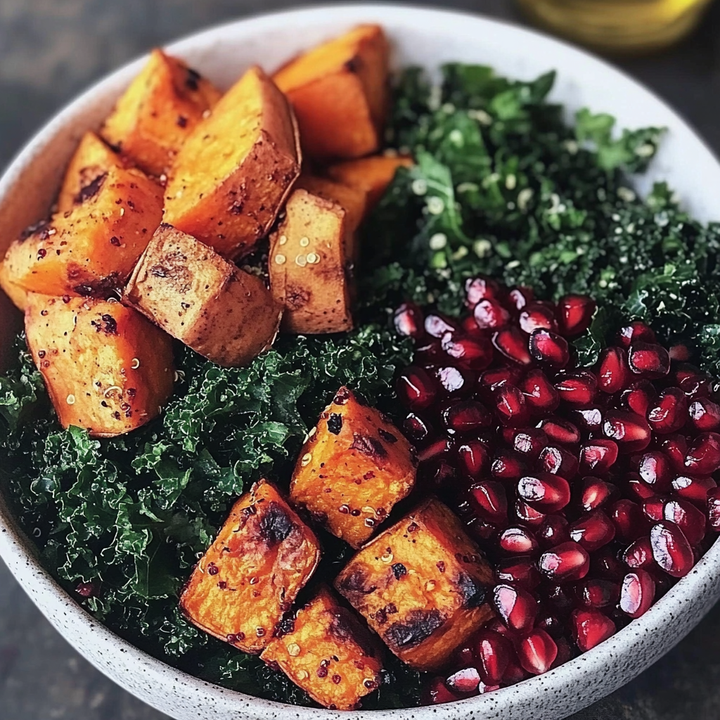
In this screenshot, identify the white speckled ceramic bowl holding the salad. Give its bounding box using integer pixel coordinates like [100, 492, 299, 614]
[0, 5, 720, 720]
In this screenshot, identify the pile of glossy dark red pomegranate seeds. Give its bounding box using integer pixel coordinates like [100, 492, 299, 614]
[395, 277, 720, 703]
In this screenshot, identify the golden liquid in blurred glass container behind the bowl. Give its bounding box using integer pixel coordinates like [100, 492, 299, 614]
[518, 0, 711, 52]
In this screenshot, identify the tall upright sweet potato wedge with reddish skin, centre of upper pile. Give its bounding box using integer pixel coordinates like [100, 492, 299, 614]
[165, 67, 301, 257]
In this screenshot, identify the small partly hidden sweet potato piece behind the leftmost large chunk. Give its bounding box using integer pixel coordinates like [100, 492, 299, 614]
[58, 132, 127, 213]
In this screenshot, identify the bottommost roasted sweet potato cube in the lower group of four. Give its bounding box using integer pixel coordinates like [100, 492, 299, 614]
[261, 585, 382, 710]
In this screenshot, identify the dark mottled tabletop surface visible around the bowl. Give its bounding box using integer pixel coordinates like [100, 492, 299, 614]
[0, 0, 720, 720]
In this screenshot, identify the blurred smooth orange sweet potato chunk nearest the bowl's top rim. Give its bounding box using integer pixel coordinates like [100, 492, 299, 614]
[274, 25, 390, 159]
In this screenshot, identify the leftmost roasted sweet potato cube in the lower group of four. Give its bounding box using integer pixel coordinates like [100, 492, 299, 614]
[180, 480, 320, 653]
